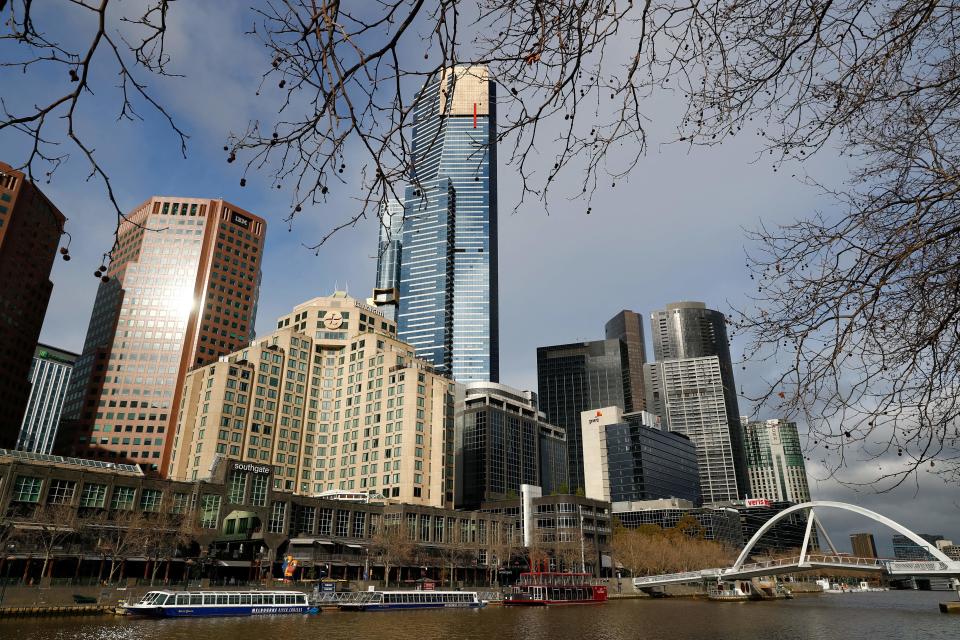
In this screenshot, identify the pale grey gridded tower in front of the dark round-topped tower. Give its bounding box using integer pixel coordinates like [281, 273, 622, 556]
[647, 356, 747, 505]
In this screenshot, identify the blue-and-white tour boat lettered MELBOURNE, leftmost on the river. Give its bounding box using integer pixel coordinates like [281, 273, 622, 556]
[123, 591, 318, 618]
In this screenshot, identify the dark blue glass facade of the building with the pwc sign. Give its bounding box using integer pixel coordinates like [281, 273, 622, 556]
[605, 418, 700, 504]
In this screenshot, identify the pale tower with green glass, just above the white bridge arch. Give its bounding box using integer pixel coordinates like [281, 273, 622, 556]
[741, 416, 810, 502]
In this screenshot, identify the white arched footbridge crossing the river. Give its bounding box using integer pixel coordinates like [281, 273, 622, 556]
[633, 500, 960, 589]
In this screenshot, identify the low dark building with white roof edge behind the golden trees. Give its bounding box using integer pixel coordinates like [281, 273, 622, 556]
[611, 498, 744, 549]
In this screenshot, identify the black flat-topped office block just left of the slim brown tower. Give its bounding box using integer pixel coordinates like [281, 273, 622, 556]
[537, 340, 628, 492]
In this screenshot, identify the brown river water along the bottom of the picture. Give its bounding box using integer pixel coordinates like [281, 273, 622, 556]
[0, 591, 960, 640]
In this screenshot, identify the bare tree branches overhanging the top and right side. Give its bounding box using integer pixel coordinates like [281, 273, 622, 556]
[0, 0, 960, 484]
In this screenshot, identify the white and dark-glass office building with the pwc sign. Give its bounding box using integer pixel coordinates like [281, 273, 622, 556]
[580, 407, 700, 504]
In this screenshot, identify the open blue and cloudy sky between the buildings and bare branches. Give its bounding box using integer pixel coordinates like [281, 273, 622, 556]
[0, 3, 960, 546]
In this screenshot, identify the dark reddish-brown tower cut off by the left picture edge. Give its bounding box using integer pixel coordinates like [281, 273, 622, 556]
[0, 162, 66, 449]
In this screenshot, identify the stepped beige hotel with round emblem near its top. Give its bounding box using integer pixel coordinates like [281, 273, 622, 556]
[169, 292, 454, 507]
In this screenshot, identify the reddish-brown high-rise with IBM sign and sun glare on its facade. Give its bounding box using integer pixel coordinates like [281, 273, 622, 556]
[61, 196, 267, 474]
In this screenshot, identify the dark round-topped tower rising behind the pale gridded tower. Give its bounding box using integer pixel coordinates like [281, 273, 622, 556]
[645, 302, 750, 502]
